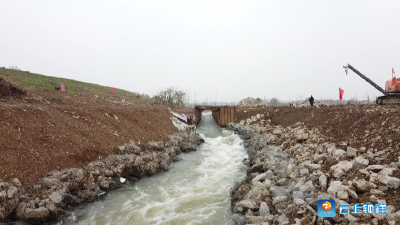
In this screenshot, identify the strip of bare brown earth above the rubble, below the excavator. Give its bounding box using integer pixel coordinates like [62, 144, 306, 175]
[238, 105, 400, 154]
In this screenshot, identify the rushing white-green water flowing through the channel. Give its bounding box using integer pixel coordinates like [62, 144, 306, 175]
[66, 112, 247, 225]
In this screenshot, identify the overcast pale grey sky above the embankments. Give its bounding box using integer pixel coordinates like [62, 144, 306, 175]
[0, 0, 400, 101]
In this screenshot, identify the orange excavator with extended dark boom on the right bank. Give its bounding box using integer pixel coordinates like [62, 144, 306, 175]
[343, 64, 400, 105]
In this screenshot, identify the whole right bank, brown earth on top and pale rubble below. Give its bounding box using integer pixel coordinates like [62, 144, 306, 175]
[229, 105, 400, 224]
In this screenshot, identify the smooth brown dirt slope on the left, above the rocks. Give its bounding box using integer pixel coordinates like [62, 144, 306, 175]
[0, 80, 193, 186]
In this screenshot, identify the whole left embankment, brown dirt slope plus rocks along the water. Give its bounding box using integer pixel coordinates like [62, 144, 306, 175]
[0, 75, 203, 224]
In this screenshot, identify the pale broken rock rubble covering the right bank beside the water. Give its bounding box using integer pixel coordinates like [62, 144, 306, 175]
[229, 115, 400, 225]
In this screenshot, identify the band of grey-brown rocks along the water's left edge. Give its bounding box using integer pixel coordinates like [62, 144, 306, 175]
[0, 133, 204, 224]
